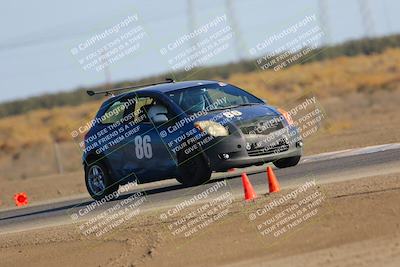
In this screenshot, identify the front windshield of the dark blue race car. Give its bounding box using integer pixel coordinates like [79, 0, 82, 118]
[168, 84, 264, 114]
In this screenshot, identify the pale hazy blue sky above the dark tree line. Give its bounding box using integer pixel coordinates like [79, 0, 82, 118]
[0, 0, 400, 102]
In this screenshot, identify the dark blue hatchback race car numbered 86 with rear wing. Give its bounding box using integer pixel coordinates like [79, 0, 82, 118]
[83, 79, 303, 199]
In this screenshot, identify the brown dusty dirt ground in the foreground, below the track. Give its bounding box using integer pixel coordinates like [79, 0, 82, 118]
[0, 173, 400, 266]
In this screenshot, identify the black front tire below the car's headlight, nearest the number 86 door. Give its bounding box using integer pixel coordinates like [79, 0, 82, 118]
[176, 154, 212, 186]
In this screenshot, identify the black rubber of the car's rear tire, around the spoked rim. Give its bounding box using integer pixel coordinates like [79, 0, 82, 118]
[85, 162, 119, 200]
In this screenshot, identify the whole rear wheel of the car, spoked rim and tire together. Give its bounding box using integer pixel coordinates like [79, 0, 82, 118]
[85, 162, 119, 200]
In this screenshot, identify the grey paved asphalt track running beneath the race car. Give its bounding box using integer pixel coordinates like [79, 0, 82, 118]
[0, 144, 400, 234]
